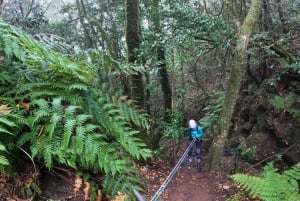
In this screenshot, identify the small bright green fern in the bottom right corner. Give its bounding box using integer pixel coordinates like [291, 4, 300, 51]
[232, 163, 300, 201]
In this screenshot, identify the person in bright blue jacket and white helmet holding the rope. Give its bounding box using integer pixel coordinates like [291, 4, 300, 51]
[188, 119, 203, 166]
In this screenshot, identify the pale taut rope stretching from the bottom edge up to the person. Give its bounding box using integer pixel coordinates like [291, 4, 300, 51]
[134, 138, 196, 201]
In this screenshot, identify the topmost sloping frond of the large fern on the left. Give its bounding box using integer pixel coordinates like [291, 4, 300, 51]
[0, 21, 93, 82]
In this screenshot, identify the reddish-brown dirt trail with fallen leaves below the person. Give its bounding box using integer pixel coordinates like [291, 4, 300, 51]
[146, 143, 233, 201]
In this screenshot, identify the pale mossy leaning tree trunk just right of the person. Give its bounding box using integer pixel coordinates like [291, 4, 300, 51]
[209, 0, 263, 170]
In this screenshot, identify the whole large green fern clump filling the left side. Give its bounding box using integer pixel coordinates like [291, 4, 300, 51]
[0, 20, 152, 199]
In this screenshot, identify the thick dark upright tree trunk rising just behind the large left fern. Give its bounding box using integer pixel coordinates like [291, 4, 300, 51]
[125, 0, 145, 107]
